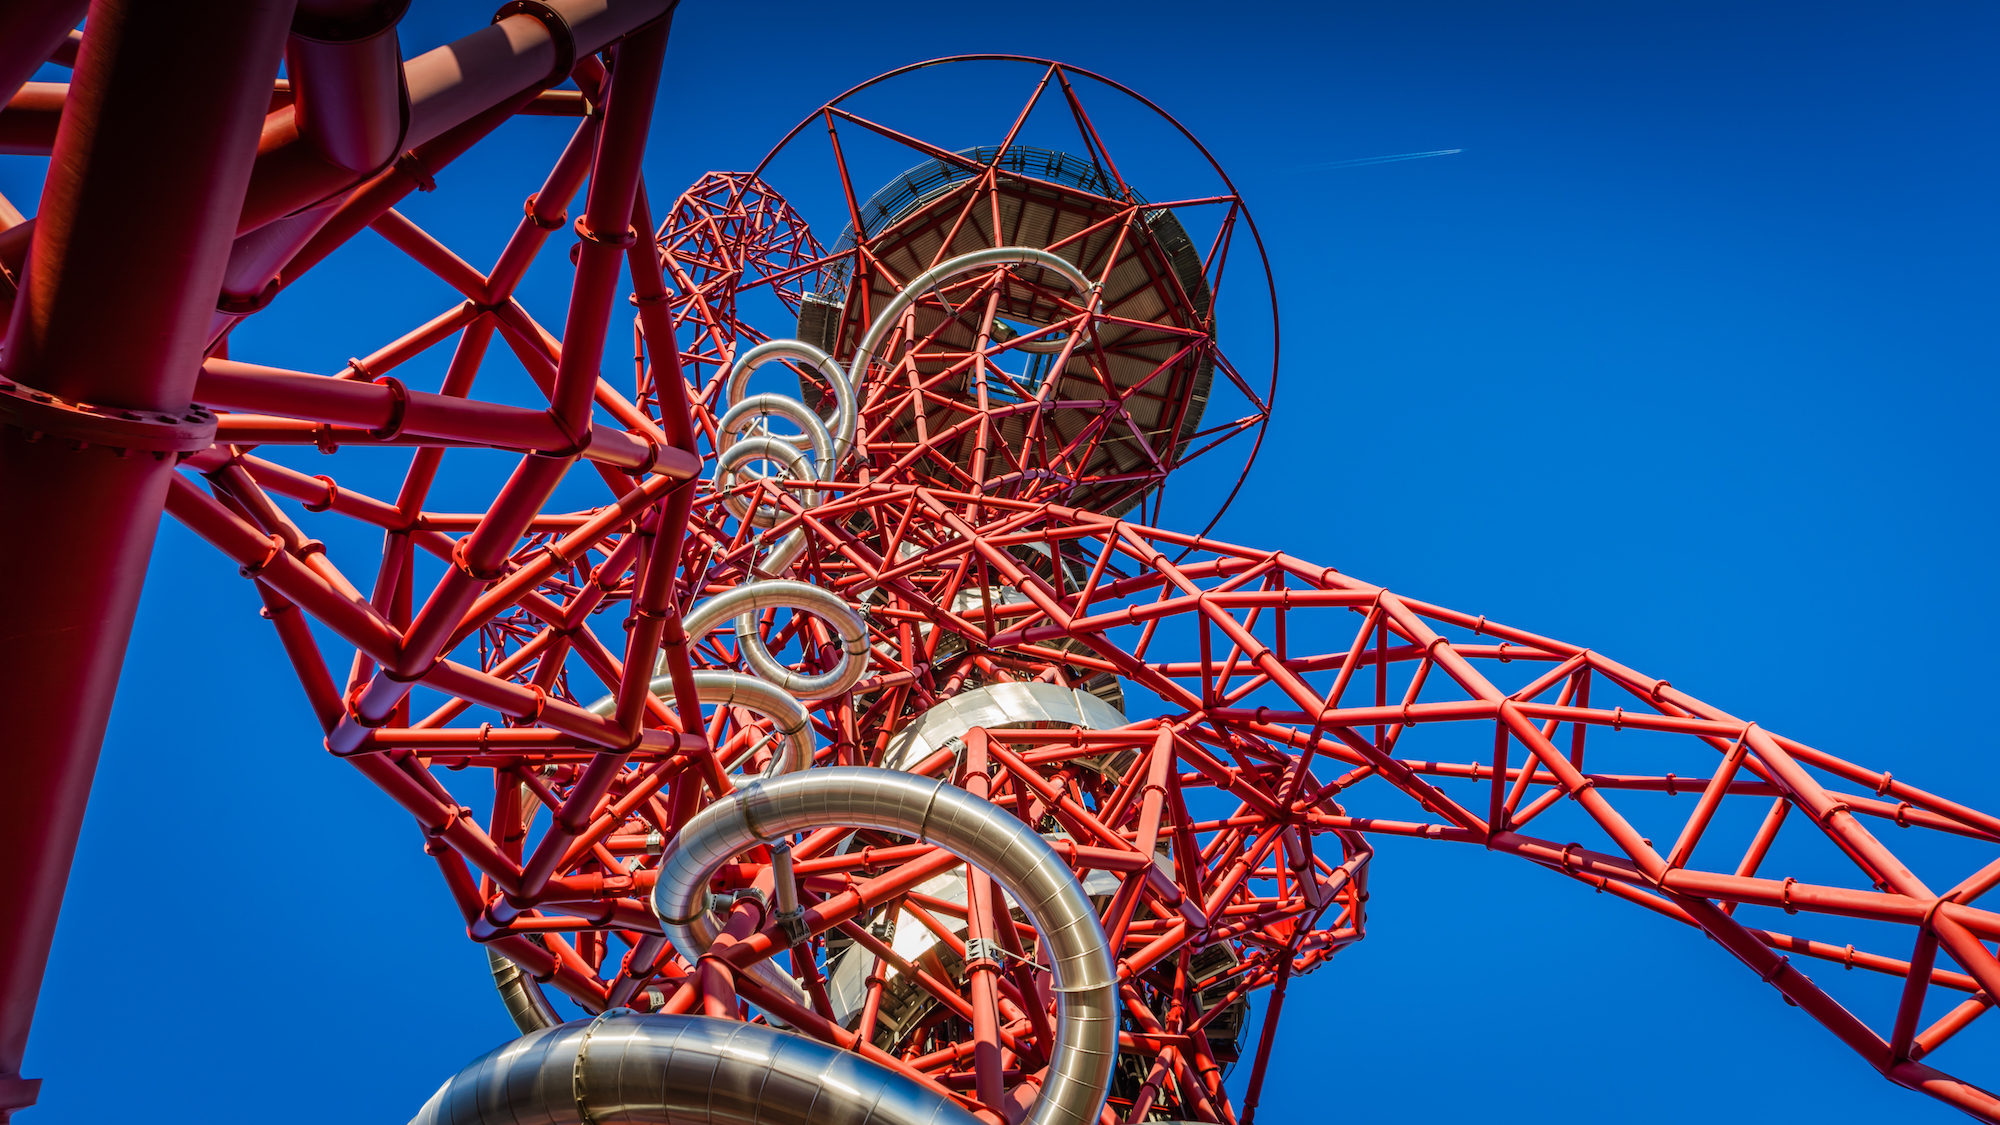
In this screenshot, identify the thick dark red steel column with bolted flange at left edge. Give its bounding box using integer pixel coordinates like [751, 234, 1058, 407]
[0, 0, 292, 1119]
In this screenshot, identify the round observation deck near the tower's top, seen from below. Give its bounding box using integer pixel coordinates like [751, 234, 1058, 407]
[798, 144, 1216, 514]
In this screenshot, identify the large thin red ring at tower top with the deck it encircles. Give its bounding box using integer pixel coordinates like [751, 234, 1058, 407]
[752, 56, 1278, 530]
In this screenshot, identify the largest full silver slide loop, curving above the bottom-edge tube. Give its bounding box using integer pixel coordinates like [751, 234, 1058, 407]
[652, 767, 1118, 1125]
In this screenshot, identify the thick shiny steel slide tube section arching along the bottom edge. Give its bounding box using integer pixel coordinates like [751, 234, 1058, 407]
[410, 1009, 978, 1125]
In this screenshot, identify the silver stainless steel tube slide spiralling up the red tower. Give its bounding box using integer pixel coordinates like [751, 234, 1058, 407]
[466, 258, 1124, 1125]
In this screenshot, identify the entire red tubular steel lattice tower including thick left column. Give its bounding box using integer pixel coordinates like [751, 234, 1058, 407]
[0, 0, 2000, 1125]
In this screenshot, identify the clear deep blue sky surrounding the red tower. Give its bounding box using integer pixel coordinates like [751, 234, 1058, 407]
[0, 0, 2000, 1125]
